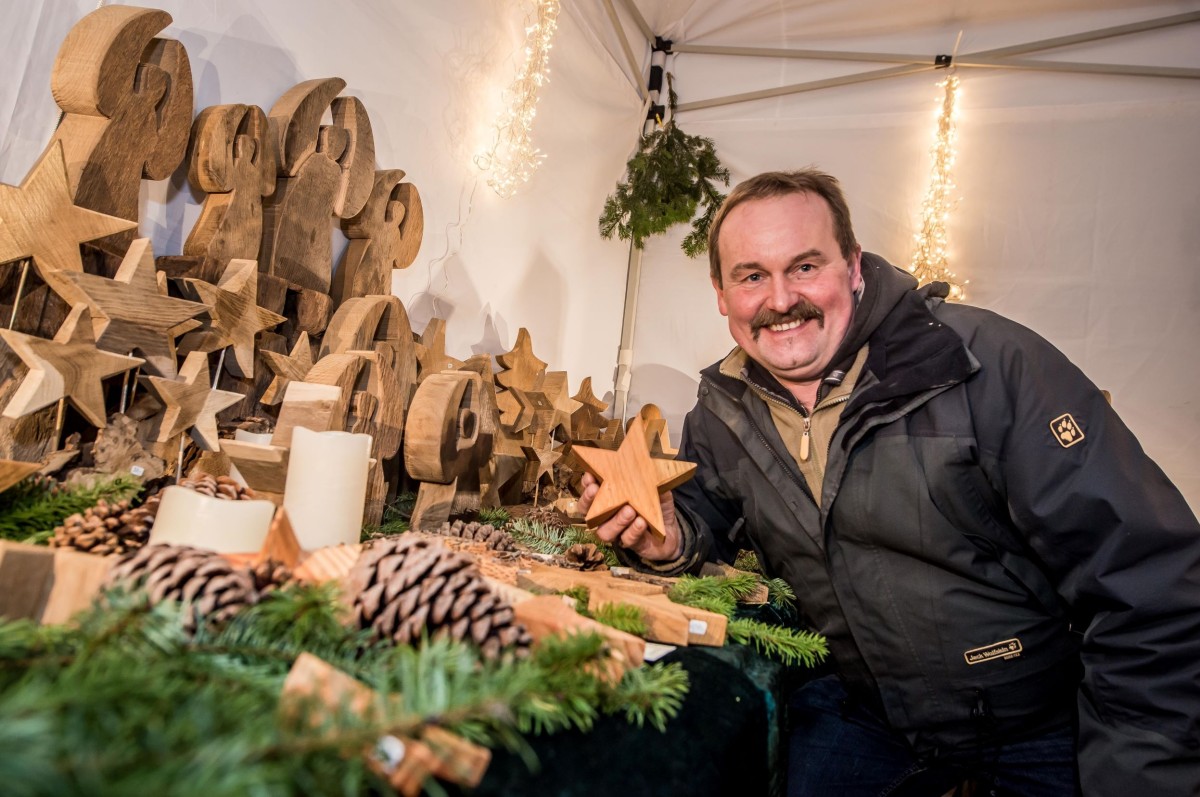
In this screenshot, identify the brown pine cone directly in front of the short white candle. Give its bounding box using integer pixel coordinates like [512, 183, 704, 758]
[106, 545, 259, 634]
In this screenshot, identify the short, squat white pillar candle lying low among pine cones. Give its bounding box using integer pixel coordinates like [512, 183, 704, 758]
[150, 485, 275, 553]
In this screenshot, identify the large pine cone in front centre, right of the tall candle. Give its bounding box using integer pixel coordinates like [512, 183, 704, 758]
[349, 534, 532, 659]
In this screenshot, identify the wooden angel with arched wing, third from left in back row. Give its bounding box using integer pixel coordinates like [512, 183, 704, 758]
[259, 78, 374, 294]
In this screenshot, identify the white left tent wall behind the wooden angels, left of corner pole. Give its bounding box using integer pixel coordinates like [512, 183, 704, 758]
[0, 0, 642, 392]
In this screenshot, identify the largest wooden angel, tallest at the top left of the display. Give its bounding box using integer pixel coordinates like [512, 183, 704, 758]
[47, 6, 192, 254]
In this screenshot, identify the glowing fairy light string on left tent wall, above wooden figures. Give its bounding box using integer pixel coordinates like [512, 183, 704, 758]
[475, 0, 559, 198]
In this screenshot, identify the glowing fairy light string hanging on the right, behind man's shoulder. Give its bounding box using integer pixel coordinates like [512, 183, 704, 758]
[908, 74, 966, 300]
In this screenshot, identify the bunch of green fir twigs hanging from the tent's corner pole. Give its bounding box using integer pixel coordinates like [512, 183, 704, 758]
[600, 74, 730, 257]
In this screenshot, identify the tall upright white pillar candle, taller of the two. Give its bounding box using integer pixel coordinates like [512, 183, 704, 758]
[283, 426, 371, 551]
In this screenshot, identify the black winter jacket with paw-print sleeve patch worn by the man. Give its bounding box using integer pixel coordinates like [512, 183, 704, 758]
[676, 254, 1200, 796]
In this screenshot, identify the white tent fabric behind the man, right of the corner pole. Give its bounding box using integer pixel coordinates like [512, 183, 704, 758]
[576, 1, 1200, 510]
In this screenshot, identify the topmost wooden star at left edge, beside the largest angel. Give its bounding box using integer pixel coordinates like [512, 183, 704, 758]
[0, 140, 138, 278]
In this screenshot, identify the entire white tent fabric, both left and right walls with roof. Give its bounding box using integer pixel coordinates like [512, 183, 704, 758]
[0, 0, 1200, 508]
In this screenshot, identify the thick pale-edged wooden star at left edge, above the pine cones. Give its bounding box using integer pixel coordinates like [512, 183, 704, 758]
[0, 304, 143, 429]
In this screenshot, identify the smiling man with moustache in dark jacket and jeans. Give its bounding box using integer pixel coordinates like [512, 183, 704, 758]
[581, 170, 1200, 797]
